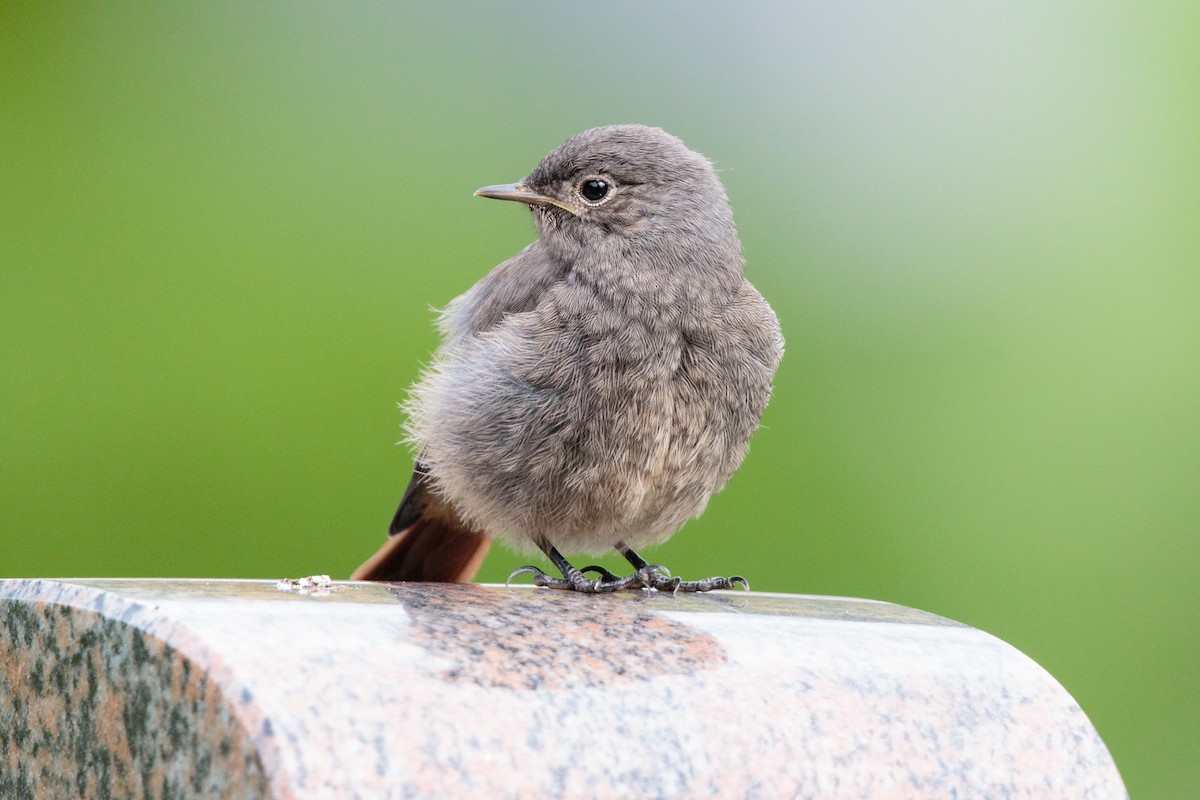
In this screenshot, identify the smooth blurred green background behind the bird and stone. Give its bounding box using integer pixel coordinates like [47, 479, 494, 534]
[0, 0, 1200, 799]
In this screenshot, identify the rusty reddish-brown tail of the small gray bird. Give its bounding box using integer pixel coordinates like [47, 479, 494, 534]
[350, 516, 492, 583]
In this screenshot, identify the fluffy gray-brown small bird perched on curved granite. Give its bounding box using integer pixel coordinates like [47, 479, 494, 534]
[353, 125, 784, 593]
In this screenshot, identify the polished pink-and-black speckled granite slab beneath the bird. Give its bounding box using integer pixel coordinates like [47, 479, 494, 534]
[0, 579, 1127, 800]
